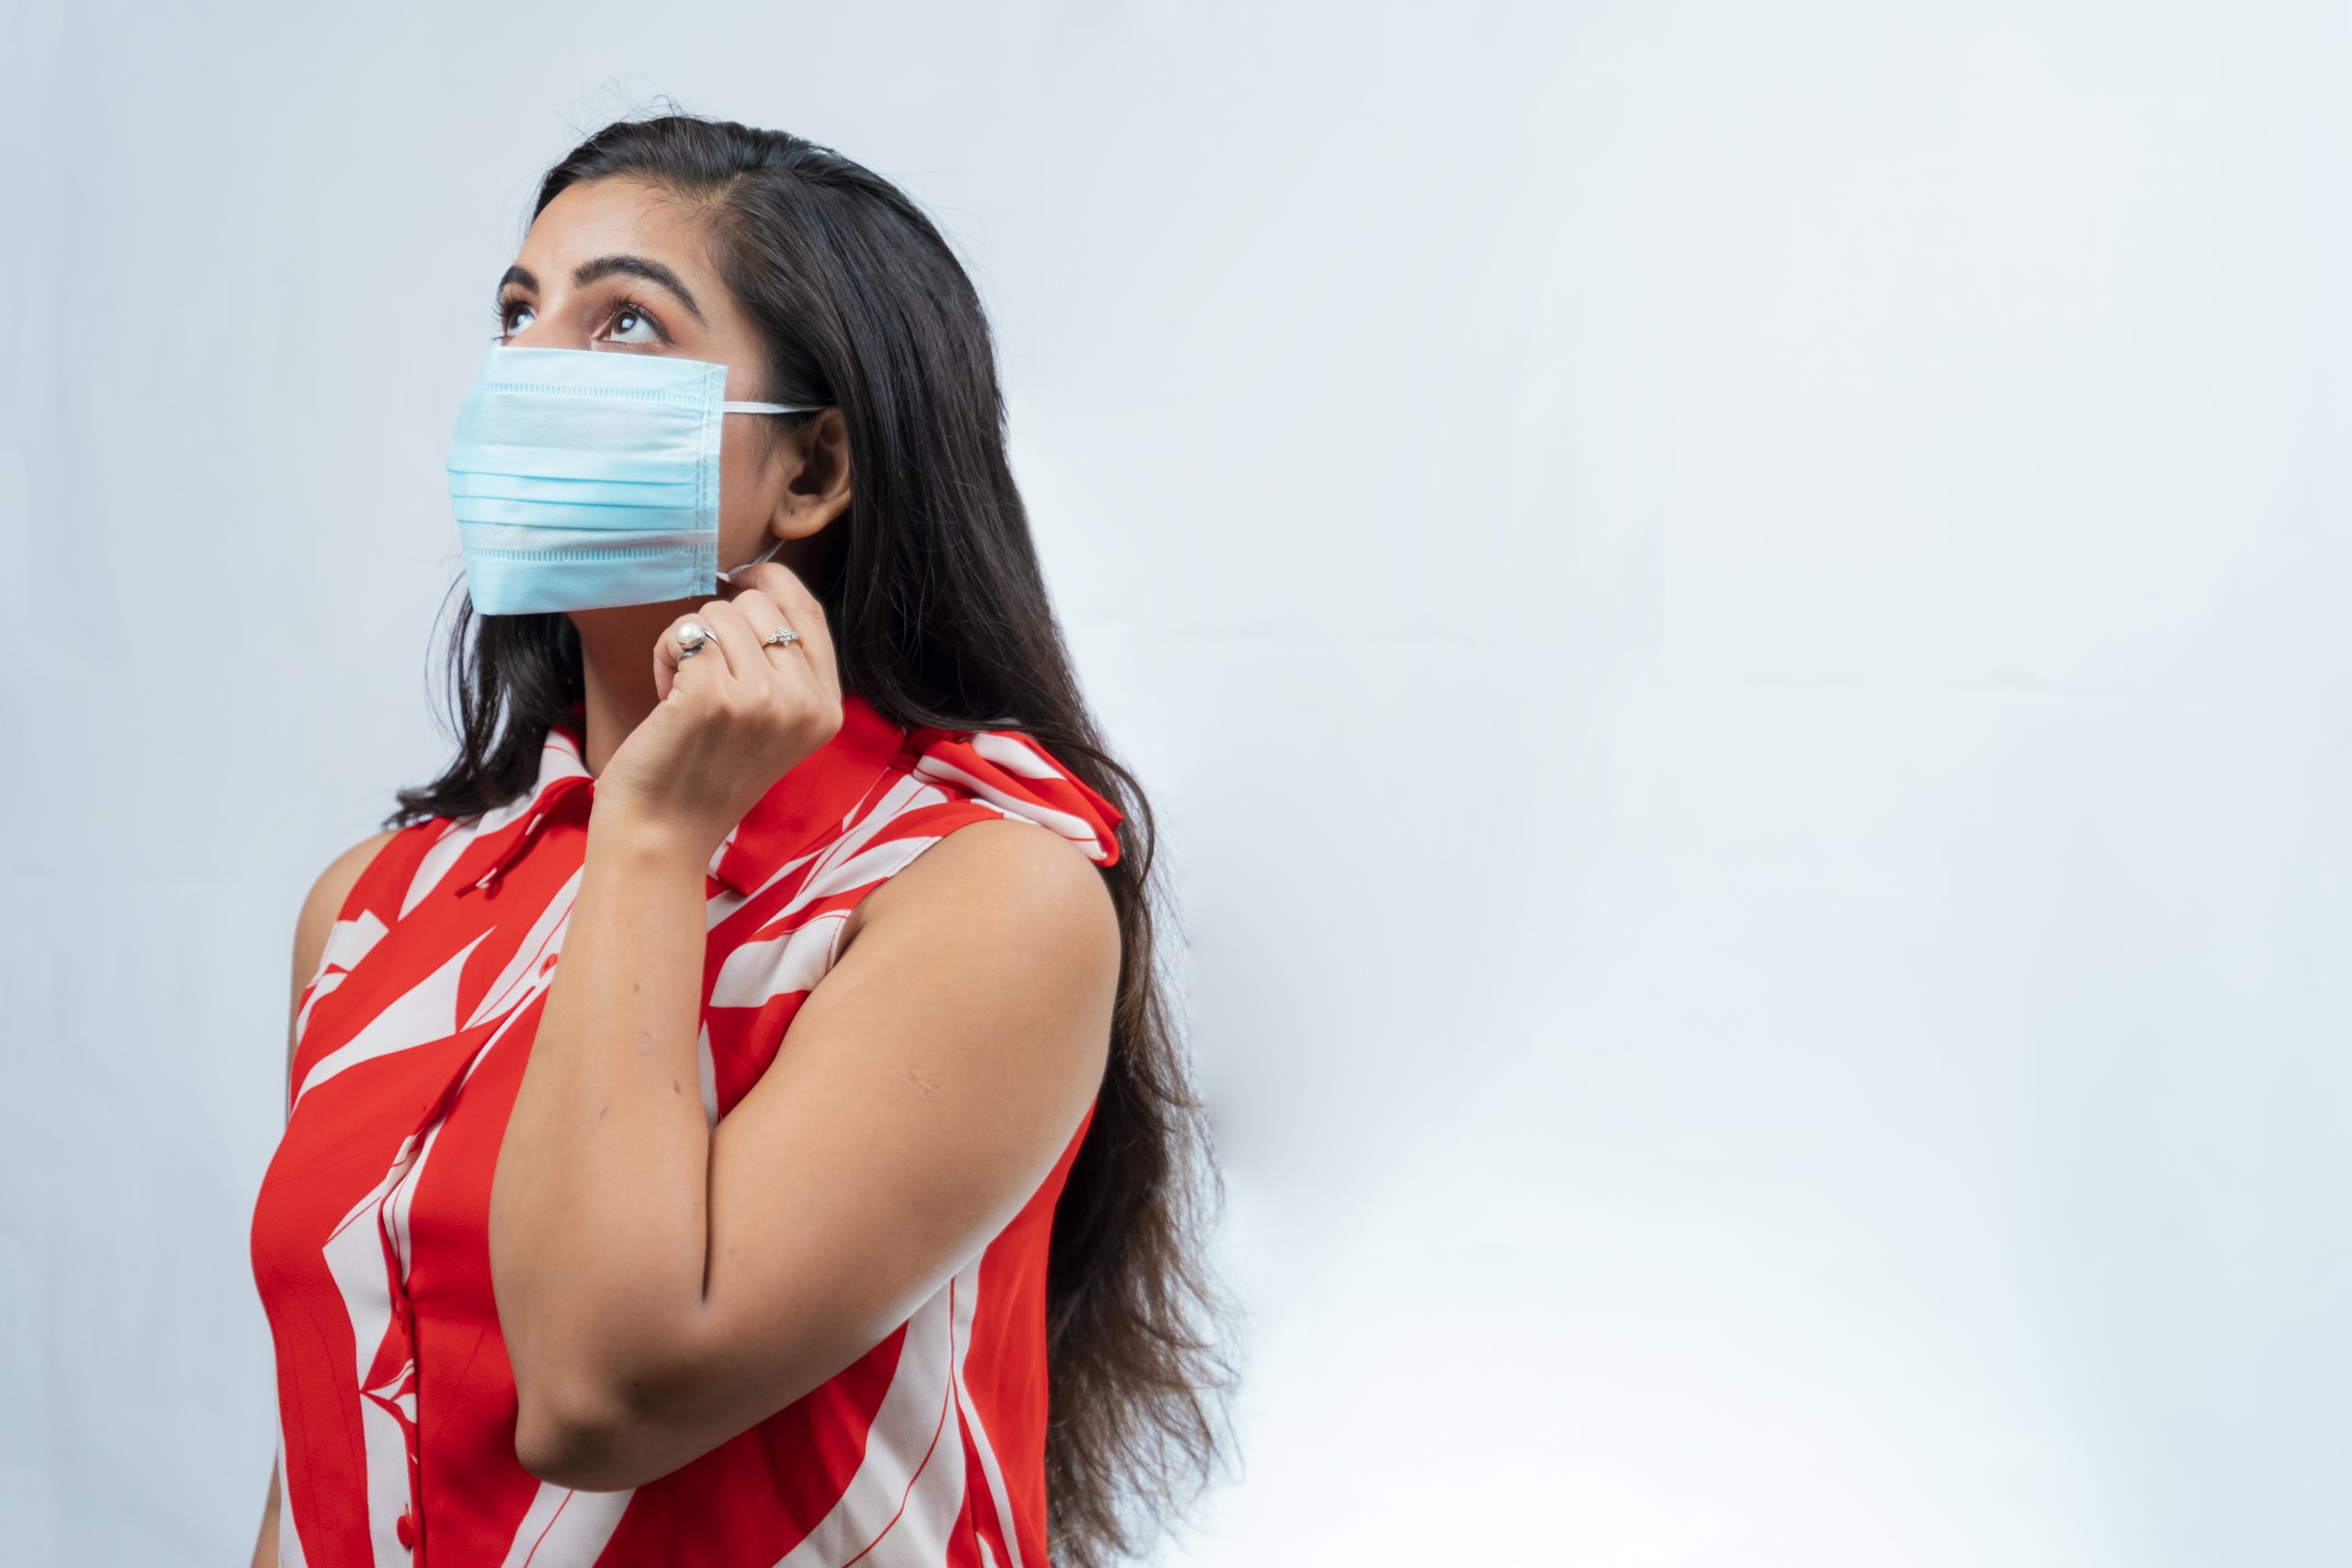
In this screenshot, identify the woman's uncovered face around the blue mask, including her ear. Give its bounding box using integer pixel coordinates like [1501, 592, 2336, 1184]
[499, 179, 849, 604]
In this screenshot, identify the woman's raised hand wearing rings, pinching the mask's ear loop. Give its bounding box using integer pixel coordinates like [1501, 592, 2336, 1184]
[595, 562, 842, 861]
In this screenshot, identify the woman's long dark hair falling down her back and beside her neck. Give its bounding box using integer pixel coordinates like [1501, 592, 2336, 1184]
[383, 115, 1238, 1568]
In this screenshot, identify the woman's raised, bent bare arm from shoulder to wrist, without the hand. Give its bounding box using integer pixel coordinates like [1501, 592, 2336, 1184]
[489, 797, 1120, 1491]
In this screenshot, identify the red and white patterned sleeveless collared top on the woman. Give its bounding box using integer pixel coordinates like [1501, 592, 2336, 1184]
[252, 694, 1120, 1568]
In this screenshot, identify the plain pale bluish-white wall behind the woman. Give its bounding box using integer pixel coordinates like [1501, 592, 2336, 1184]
[0, 0, 2352, 1568]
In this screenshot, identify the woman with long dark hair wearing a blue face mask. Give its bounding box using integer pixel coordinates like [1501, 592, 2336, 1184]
[252, 115, 1230, 1568]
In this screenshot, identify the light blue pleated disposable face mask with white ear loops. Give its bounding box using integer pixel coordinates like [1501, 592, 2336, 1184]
[449, 345, 814, 616]
